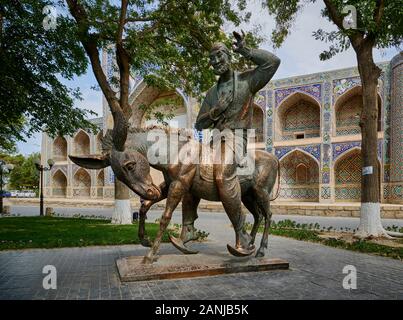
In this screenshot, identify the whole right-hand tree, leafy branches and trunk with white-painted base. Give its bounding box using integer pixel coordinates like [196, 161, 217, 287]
[266, 0, 403, 238]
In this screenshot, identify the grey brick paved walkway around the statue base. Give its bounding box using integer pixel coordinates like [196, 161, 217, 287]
[0, 212, 403, 300]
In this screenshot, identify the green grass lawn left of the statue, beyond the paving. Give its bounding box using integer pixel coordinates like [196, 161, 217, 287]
[0, 217, 172, 250]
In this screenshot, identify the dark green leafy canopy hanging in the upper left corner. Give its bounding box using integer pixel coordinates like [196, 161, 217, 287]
[0, 0, 95, 151]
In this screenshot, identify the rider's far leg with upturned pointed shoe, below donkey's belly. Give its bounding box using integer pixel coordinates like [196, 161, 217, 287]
[169, 192, 200, 254]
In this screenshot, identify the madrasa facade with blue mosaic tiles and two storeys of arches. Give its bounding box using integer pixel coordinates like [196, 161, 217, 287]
[41, 52, 403, 204]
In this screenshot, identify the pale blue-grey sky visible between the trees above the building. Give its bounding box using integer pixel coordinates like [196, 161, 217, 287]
[17, 0, 399, 155]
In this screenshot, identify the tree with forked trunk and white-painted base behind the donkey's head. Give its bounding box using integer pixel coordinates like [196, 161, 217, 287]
[66, 0, 253, 222]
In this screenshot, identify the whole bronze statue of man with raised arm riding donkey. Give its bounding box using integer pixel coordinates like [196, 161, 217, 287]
[70, 32, 280, 263]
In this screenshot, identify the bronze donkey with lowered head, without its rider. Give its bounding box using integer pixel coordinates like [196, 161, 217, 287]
[69, 122, 279, 263]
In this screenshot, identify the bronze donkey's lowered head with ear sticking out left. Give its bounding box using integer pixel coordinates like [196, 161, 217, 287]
[69, 149, 161, 200]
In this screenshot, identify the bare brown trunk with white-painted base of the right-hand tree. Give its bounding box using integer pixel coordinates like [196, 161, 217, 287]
[356, 45, 387, 238]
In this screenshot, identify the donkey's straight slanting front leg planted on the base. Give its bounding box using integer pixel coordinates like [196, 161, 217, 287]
[143, 165, 196, 264]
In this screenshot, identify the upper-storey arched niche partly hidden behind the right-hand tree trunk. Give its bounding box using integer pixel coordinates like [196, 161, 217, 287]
[334, 86, 382, 136]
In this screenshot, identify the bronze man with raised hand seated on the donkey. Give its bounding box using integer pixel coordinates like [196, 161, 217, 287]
[195, 31, 280, 258]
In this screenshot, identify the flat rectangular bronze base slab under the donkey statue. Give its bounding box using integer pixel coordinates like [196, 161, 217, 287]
[116, 254, 289, 282]
